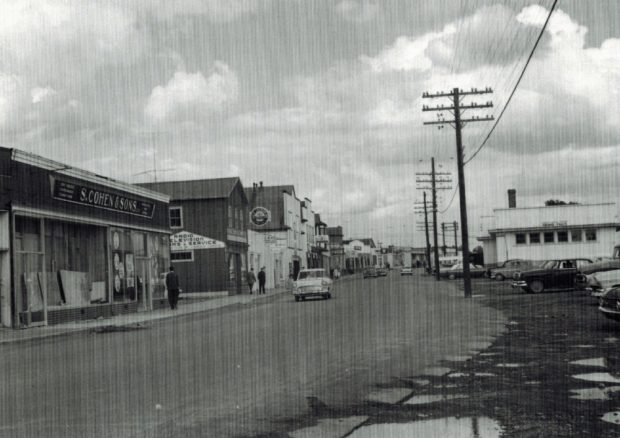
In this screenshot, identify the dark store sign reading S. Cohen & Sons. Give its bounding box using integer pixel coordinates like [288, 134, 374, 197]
[50, 177, 155, 218]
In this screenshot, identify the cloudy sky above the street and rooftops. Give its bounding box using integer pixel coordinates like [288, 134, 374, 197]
[0, 0, 620, 245]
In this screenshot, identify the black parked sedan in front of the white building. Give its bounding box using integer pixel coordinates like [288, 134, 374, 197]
[512, 259, 592, 293]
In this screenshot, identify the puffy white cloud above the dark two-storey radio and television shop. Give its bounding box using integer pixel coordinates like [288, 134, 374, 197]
[144, 61, 239, 123]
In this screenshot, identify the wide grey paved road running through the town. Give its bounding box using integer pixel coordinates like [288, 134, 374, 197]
[0, 272, 499, 437]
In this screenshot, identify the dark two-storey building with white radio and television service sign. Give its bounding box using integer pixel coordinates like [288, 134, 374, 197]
[141, 177, 248, 295]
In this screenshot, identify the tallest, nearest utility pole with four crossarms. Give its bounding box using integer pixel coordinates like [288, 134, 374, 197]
[422, 87, 494, 298]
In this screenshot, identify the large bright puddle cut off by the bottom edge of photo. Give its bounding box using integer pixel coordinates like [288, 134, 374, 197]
[350, 417, 502, 438]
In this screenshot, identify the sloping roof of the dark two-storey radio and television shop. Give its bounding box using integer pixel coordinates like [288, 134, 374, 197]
[139, 176, 245, 200]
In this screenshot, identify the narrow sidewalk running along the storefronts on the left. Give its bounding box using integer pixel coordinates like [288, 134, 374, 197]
[0, 288, 289, 345]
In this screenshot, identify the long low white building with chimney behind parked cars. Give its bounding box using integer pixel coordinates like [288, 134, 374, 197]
[478, 200, 620, 264]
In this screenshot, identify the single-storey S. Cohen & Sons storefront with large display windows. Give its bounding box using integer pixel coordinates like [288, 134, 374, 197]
[0, 148, 170, 328]
